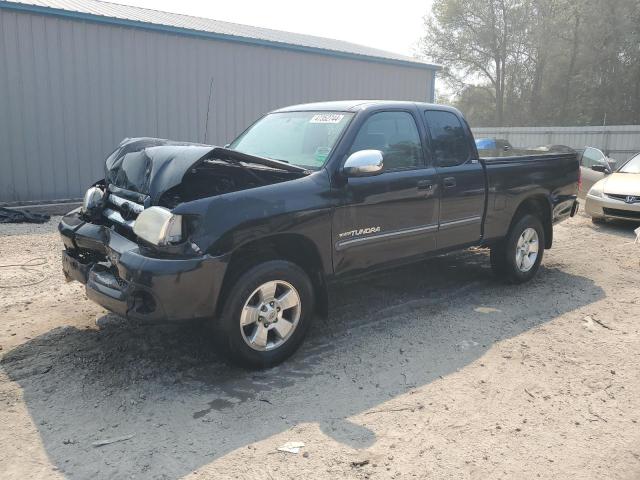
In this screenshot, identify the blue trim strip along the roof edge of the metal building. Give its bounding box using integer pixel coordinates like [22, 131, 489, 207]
[0, 0, 442, 71]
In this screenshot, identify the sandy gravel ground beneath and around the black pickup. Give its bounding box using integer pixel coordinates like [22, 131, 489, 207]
[0, 216, 640, 480]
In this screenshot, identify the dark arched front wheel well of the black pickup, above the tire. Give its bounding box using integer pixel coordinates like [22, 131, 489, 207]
[218, 234, 329, 315]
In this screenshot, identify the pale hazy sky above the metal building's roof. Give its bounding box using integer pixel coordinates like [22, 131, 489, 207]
[112, 0, 432, 56]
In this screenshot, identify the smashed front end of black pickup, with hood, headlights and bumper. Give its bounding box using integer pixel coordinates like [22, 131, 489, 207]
[59, 138, 306, 321]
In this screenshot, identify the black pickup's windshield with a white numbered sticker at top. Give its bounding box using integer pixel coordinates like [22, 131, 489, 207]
[229, 112, 353, 169]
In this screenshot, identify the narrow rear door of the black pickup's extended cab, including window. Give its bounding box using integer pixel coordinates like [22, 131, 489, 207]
[424, 110, 485, 249]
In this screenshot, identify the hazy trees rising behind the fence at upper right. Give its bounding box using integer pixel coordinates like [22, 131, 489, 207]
[422, 0, 640, 126]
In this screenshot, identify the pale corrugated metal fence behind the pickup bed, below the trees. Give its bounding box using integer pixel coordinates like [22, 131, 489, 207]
[472, 125, 640, 162]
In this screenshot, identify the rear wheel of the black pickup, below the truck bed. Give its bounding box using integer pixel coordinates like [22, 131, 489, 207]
[491, 214, 545, 284]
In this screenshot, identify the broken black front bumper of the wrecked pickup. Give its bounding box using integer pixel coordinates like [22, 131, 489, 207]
[58, 210, 228, 322]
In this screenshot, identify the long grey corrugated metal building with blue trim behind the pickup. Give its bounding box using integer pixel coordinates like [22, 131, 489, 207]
[0, 0, 438, 204]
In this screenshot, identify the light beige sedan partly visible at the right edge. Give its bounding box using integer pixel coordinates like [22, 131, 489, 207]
[585, 153, 640, 223]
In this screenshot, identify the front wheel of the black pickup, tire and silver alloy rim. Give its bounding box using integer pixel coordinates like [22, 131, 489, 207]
[214, 260, 315, 369]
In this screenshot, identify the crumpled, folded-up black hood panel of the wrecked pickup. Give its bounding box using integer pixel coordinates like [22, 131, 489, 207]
[105, 138, 215, 204]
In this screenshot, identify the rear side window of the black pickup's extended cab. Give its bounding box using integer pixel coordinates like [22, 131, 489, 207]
[424, 110, 471, 167]
